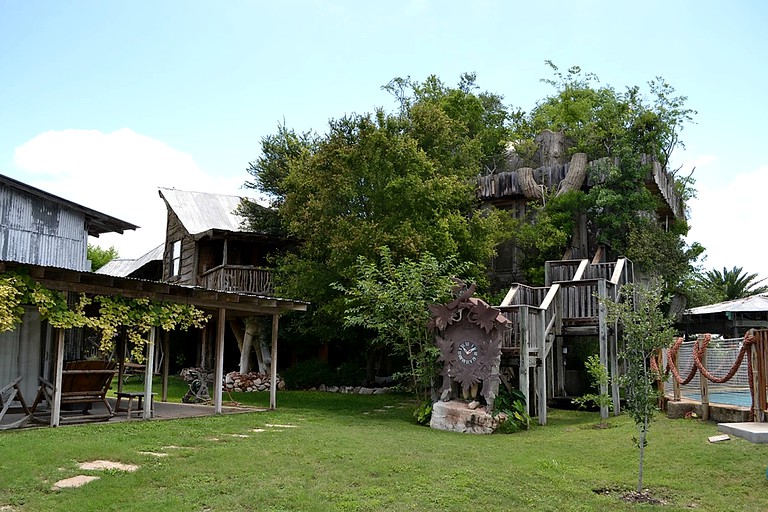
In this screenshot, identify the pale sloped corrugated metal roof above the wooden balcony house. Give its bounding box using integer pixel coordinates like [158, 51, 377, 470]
[159, 188, 251, 235]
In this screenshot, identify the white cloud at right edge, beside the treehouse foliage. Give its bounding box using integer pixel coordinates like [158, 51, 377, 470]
[688, 165, 768, 278]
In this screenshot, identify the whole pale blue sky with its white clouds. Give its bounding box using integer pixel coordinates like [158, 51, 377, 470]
[0, 0, 768, 278]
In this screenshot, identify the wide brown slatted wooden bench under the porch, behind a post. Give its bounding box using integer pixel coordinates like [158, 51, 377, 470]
[31, 361, 117, 421]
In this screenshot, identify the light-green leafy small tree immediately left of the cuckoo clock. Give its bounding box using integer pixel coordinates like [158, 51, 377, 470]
[334, 247, 464, 404]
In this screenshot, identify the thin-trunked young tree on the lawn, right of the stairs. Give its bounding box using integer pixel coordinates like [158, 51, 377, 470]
[601, 284, 676, 493]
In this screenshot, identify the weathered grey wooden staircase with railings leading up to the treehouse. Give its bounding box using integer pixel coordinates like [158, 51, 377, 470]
[498, 258, 635, 425]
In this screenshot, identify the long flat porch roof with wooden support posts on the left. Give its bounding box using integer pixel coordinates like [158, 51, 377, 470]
[0, 261, 308, 427]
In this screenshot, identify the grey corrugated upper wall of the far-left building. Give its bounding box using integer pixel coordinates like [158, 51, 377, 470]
[0, 184, 91, 271]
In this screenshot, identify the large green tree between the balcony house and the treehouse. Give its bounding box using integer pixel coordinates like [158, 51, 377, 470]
[246, 75, 508, 352]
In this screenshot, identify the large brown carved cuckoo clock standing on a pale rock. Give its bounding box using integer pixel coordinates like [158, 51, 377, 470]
[428, 280, 509, 411]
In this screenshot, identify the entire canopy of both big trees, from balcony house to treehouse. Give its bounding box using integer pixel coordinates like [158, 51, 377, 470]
[241, 62, 703, 360]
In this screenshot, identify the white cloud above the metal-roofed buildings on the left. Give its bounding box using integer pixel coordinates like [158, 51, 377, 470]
[15, 128, 251, 258]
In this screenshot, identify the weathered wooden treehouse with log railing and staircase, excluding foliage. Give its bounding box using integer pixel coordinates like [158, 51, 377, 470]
[477, 131, 684, 424]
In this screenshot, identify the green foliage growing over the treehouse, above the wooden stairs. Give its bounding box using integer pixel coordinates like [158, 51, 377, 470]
[512, 61, 703, 292]
